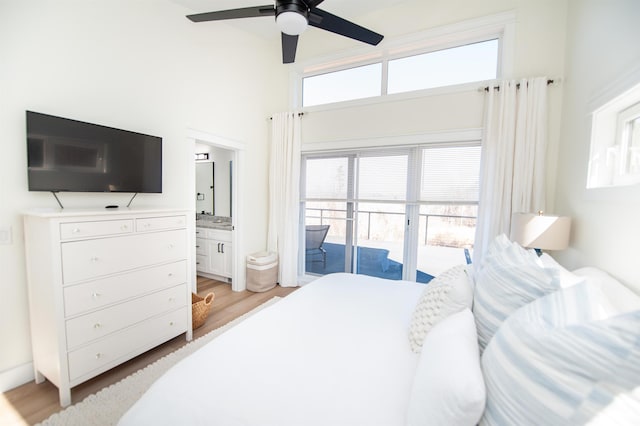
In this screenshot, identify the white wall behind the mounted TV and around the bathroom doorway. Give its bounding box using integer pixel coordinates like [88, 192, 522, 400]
[0, 0, 286, 386]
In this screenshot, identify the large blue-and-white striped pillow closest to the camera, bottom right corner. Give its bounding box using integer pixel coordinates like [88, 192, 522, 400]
[480, 284, 640, 425]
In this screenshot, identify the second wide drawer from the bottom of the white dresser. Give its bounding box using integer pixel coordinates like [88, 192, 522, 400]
[66, 284, 187, 348]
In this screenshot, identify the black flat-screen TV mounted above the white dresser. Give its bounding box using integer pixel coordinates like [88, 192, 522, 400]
[27, 111, 162, 193]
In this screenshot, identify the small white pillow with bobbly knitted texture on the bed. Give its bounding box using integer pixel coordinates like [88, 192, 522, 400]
[409, 265, 473, 353]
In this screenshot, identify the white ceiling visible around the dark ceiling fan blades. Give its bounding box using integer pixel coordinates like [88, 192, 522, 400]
[170, 0, 404, 40]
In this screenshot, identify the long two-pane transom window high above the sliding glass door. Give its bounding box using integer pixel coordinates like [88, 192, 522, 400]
[302, 38, 500, 107]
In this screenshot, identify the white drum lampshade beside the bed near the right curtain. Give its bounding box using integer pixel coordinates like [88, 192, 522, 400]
[511, 213, 571, 250]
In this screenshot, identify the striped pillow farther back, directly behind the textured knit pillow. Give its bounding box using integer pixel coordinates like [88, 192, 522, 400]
[473, 244, 560, 351]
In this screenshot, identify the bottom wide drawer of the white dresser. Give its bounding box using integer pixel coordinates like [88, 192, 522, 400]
[68, 308, 190, 386]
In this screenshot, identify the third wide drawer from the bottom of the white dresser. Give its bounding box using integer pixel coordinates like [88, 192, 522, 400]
[64, 260, 187, 317]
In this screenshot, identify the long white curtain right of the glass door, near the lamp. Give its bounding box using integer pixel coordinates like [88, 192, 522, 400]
[473, 77, 547, 262]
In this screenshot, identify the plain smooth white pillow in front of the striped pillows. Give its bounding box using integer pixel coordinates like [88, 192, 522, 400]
[407, 309, 486, 426]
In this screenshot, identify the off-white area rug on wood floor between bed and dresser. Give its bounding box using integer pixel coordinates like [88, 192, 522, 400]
[39, 297, 280, 426]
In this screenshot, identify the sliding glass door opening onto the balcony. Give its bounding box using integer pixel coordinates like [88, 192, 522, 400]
[301, 144, 480, 282]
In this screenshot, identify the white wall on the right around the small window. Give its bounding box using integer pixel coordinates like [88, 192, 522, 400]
[556, 0, 640, 291]
